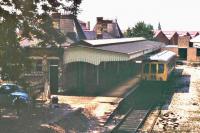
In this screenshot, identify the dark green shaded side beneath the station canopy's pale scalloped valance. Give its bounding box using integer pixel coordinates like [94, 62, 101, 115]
[63, 61, 141, 95]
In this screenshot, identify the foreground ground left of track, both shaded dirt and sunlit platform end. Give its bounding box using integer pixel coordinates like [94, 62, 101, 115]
[0, 96, 120, 133]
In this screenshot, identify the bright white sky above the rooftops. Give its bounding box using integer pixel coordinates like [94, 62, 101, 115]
[78, 0, 200, 31]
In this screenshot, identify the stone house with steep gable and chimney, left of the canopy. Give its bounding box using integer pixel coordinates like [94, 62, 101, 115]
[21, 13, 86, 93]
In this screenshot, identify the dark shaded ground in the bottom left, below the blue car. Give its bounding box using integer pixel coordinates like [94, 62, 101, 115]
[0, 103, 95, 133]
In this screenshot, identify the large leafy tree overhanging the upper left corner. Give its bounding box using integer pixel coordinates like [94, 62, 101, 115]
[0, 0, 82, 81]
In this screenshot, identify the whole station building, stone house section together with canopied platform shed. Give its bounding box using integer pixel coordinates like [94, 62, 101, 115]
[21, 14, 164, 94]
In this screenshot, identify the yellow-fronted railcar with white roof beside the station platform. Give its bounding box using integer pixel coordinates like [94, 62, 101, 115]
[141, 50, 176, 81]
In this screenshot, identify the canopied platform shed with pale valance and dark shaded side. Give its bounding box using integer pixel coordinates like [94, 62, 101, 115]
[63, 38, 164, 94]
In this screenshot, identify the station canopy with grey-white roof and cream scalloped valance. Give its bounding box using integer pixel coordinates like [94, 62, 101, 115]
[64, 37, 165, 65]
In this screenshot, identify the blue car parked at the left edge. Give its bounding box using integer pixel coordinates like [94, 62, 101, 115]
[0, 83, 30, 106]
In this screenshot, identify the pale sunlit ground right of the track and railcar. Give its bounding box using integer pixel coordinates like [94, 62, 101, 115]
[153, 65, 200, 133]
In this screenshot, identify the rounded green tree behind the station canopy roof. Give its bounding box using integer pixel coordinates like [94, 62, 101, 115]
[125, 22, 154, 40]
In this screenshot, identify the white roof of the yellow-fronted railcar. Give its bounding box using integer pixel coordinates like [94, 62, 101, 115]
[150, 50, 176, 61]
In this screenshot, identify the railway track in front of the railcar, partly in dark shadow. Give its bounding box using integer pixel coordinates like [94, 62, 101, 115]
[109, 82, 166, 133]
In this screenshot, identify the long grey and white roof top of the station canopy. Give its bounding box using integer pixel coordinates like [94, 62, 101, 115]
[77, 38, 165, 55]
